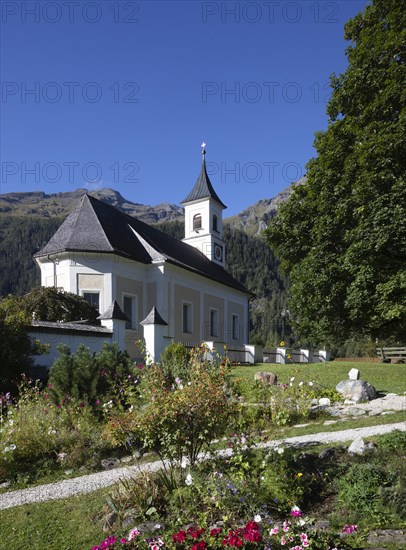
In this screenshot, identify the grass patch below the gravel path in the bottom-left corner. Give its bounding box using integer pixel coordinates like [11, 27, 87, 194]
[0, 488, 111, 550]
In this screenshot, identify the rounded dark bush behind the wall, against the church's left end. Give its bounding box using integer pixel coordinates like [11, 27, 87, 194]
[20, 287, 99, 323]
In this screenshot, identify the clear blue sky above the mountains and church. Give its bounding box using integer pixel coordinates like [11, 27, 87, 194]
[0, 0, 367, 216]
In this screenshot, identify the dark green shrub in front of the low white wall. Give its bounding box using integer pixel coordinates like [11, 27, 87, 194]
[49, 342, 133, 406]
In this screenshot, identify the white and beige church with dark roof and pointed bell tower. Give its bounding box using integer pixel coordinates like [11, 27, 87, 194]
[34, 149, 252, 357]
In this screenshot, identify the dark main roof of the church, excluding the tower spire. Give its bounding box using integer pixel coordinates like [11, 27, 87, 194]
[34, 195, 252, 294]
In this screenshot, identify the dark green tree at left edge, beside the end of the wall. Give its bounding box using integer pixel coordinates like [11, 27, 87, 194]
[0, 295, 46, 393]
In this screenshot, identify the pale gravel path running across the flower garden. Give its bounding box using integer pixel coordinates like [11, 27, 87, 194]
[0, 422, 406, 510]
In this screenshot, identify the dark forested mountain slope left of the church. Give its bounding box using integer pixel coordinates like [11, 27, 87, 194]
[0, 219, 63, 296]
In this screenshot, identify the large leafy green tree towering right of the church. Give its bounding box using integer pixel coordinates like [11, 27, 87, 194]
[267, 0, 406, 345]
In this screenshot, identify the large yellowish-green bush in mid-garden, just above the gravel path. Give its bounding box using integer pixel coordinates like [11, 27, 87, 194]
[105, 349, 236, 464]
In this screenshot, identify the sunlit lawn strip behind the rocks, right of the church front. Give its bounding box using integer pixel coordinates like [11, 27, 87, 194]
[232, 361, 406, 394]
